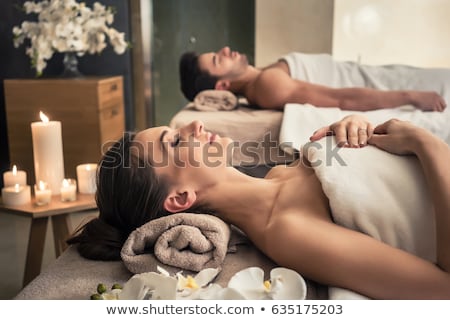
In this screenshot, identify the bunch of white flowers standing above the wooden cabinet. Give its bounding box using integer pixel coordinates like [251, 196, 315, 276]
[13, 0, 128, 76]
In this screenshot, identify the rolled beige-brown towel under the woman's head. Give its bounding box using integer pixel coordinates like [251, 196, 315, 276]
[121, 213, 230, 273]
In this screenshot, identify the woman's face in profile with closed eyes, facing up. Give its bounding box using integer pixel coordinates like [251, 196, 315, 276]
[133, 121, 233, 181]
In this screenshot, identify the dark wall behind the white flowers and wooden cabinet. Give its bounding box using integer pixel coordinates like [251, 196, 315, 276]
[0, 0, 134, 187]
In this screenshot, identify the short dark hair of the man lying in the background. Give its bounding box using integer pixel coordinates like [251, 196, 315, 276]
[179, 52, 219, 101]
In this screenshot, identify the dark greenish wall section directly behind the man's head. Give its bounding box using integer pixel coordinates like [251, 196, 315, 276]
[152, 0, 255, 125]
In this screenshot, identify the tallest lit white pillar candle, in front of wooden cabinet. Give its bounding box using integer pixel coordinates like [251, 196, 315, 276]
[31, 112, 64, 194]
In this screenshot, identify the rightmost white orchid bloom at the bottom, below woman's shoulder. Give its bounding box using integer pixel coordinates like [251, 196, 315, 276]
[228, 267, 306, 300]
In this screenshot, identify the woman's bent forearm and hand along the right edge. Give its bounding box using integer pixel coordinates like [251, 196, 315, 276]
[369, 120, 450, 272]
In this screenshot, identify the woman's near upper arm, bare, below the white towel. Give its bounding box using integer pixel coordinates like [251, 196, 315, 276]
[267, 212, 450, 299]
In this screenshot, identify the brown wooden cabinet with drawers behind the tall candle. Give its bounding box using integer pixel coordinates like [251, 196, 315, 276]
[4, 76, 125, 184]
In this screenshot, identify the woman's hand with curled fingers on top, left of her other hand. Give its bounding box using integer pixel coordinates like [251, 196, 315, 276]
[309, 115, 374, 148]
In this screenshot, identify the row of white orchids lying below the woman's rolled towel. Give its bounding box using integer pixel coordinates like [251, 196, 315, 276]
[91, 267, 307, 300]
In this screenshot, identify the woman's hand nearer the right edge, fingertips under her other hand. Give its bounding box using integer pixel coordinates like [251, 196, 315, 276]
[368, 119, 432, 155]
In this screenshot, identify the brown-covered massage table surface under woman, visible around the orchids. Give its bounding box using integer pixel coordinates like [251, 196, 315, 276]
[14, 238, 327, 300]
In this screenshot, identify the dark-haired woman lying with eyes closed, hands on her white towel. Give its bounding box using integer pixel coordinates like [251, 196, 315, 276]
[69, 116, 450, 299]
